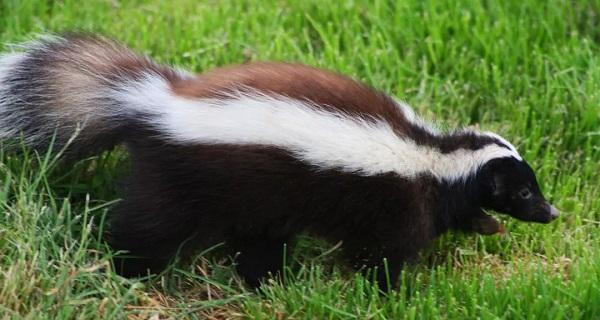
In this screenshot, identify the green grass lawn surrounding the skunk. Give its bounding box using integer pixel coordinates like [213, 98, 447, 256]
[0, 0, 600, 319]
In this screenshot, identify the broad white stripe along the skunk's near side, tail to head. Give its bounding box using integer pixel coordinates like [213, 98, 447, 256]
[113, 75, 513, 181]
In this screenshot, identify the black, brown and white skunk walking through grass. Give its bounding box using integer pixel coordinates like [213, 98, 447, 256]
[0, 35, 558, 285]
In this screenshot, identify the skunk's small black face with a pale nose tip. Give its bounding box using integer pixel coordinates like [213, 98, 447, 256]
[477, 157, 558, 223]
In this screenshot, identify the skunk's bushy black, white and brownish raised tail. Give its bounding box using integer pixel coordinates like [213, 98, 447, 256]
[0, 35, 183, 153]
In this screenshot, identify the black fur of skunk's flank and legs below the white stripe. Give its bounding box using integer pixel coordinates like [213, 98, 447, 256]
[111, 131, 548, 285]
